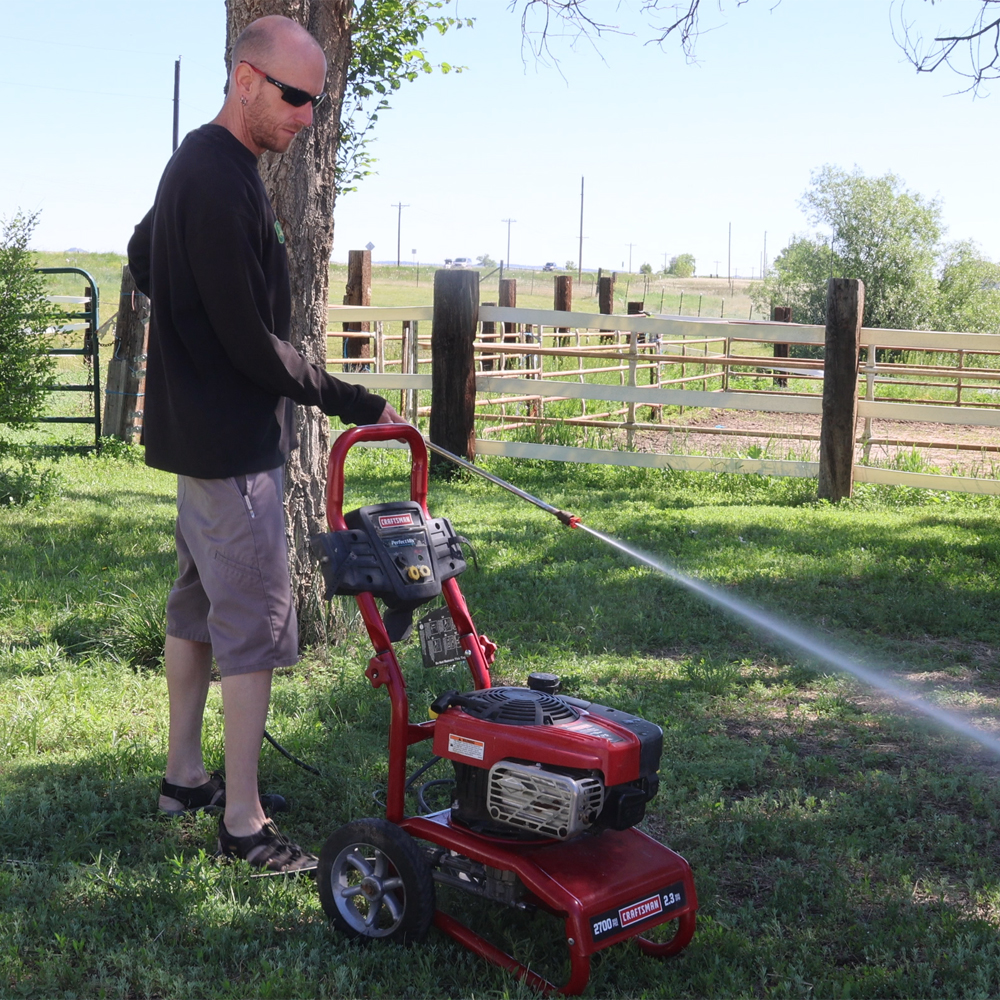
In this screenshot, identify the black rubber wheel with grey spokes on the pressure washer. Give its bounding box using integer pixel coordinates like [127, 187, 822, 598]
[316, 819, 434, 944]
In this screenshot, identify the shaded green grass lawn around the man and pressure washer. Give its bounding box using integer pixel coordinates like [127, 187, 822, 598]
[0, 450, 1000, 998]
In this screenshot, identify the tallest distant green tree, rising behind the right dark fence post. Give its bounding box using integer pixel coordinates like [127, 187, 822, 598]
[802, 164, 941, 329]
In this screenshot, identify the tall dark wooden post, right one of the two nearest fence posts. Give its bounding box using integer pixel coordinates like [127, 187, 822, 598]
[819, 278, 865, 503]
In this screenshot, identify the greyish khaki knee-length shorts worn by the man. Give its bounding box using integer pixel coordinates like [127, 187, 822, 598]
[167, 468, 298, 677]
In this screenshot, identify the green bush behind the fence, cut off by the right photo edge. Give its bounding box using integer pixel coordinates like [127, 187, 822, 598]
[933, 240, 1000, 333]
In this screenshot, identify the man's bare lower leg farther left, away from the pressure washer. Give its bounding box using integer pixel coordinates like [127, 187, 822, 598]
[160, 635, 212, 810]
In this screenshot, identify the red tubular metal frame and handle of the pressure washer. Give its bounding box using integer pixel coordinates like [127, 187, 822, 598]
[326, 424, 697, 996]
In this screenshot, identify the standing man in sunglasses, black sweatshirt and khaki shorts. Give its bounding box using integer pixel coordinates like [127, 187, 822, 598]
[129, 16, 403, 872]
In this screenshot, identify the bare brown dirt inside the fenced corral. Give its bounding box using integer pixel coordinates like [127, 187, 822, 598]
[635, 410, 1000, 478]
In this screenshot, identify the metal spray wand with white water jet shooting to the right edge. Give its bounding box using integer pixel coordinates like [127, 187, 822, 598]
[425, 439, 1000, 757]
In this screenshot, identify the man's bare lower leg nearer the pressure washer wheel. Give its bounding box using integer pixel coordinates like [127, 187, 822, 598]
[216, 670, 271, 837]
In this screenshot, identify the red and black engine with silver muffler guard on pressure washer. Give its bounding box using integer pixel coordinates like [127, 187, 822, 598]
[431, 687, 663, 840]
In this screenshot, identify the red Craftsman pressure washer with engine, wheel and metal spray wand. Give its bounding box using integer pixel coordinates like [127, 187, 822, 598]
[311, 424, 698, 995]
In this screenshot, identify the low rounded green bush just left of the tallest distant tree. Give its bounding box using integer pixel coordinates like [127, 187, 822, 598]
[749, 235, 842, 323]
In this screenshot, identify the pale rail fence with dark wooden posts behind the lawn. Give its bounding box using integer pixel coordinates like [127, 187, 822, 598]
[328, 271, 1000, 499]
